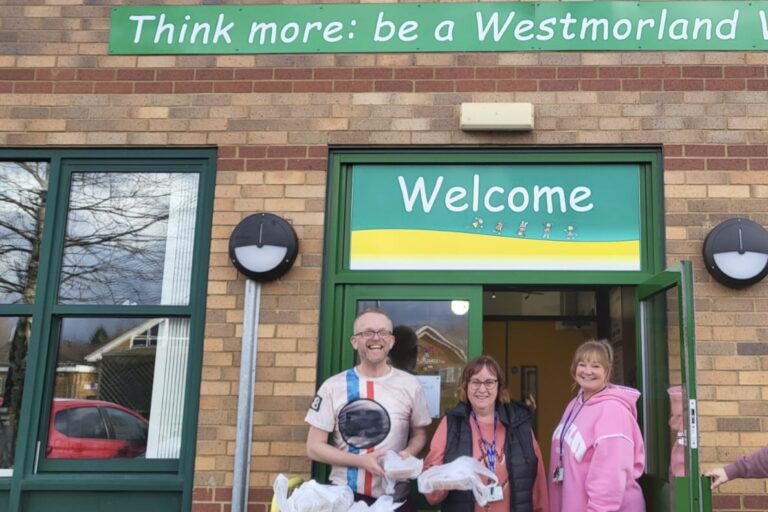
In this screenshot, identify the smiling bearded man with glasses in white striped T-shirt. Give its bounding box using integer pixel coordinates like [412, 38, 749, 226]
[304, 309, 432, 512]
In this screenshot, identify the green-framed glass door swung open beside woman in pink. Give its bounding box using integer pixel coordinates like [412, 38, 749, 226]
[636, 261, 712, 512]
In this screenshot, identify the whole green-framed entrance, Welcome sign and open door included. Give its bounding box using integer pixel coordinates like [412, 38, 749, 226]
[318, 148, 706, 512]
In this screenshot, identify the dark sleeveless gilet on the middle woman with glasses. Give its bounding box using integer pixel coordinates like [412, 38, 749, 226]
[440, 402, 538, 512]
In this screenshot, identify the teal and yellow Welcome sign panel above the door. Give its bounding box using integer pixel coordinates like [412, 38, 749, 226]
[349, 164, 641, 271]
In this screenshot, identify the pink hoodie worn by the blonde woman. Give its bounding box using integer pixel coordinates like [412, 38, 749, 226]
[549, 384, 645, 512]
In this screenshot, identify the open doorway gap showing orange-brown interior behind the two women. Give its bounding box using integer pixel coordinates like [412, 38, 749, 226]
[483, 286, 638, 470]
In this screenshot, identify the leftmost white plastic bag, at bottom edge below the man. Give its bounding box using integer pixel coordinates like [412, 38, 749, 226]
[272, 474, 355, 512]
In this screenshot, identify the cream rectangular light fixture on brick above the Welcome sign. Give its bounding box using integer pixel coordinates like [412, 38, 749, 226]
[460, 103, 533, 131]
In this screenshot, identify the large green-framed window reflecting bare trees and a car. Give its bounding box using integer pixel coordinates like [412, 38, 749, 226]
[0, 149, 216, 476]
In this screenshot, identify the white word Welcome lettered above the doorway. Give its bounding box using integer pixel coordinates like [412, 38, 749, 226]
[397, 174, 594, 214]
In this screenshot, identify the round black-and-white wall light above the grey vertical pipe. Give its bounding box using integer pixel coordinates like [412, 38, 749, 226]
[229, 213, 299, 282]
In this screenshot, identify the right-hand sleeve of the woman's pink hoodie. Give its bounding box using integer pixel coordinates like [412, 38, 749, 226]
[586, 405, 635, 512]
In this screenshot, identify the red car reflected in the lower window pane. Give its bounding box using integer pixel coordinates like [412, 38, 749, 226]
[46, 398, 149, 459]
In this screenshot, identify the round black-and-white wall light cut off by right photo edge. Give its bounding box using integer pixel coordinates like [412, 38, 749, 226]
[702, 218, 768, 288]
